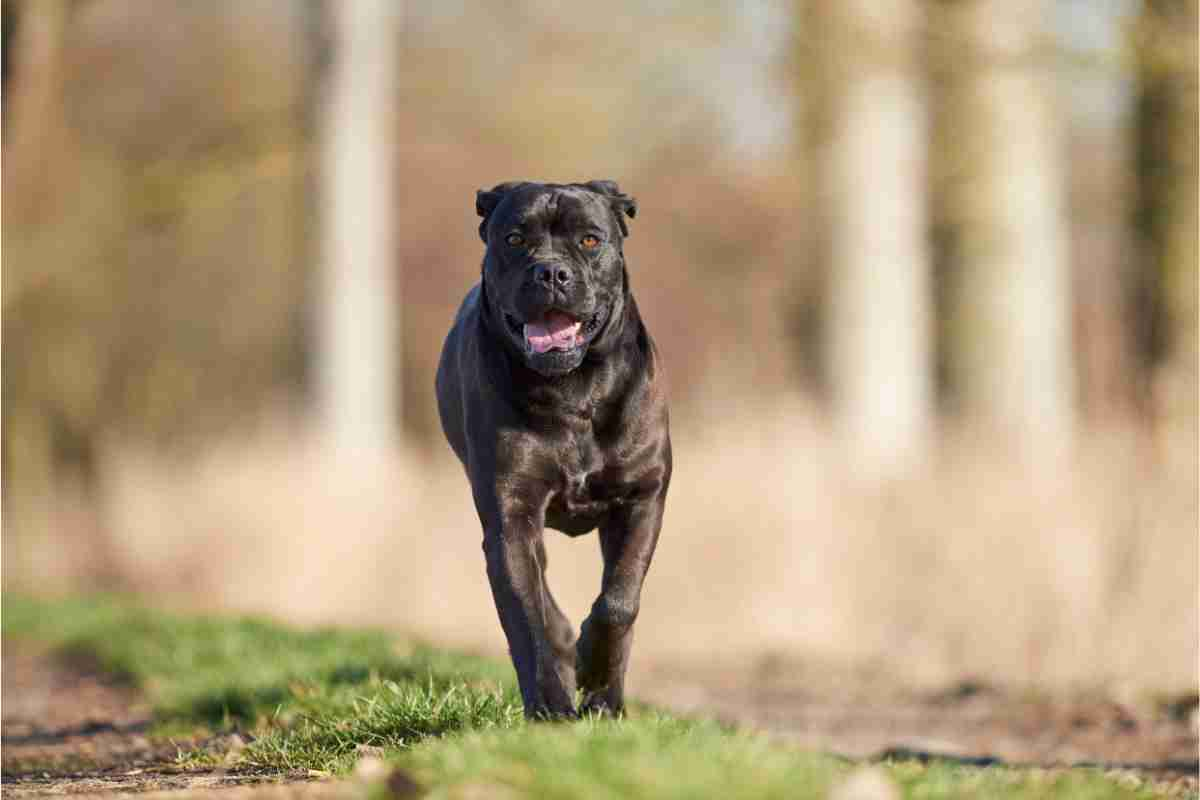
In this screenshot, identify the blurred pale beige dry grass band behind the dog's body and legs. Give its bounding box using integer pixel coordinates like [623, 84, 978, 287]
[5, 402, 1198, 691]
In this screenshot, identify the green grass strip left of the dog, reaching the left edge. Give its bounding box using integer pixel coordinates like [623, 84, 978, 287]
[2, 596, 522, 772]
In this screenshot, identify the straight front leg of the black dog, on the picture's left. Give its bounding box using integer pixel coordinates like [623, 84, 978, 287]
[480, 504, 575, 718]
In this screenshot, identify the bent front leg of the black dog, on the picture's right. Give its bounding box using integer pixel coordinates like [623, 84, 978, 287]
[576, 492, 665, 716]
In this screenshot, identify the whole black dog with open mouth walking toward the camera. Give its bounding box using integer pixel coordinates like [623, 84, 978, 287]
[437, 181, 671, 717]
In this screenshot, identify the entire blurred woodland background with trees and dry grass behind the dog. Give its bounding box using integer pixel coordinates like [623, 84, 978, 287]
[2, 0, 1200, 691]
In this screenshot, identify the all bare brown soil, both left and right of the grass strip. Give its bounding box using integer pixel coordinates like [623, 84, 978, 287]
[2, 643, 1200, 799]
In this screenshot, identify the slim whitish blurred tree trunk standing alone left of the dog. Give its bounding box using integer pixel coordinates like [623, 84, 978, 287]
[317, 0, 401, 455]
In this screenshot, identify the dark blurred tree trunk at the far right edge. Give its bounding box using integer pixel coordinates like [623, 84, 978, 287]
[1134, 0, 1200, 431]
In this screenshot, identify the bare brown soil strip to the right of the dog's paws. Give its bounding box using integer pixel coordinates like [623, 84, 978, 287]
[634, 663, 1200, 794]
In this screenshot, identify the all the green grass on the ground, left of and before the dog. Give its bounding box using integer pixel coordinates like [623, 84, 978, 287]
[2, 596, 1152, 800]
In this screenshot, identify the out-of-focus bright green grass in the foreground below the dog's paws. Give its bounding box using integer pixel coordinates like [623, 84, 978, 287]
[400, 715, 1153, 800]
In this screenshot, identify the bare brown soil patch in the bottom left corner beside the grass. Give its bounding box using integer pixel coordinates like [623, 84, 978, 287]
[0, 640, 328, 796]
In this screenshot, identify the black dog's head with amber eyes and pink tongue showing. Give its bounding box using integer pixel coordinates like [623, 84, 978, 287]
[475, 181, 637, 375]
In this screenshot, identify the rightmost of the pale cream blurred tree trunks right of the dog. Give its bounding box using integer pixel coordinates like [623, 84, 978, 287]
[936, 0, 1075, 464]
